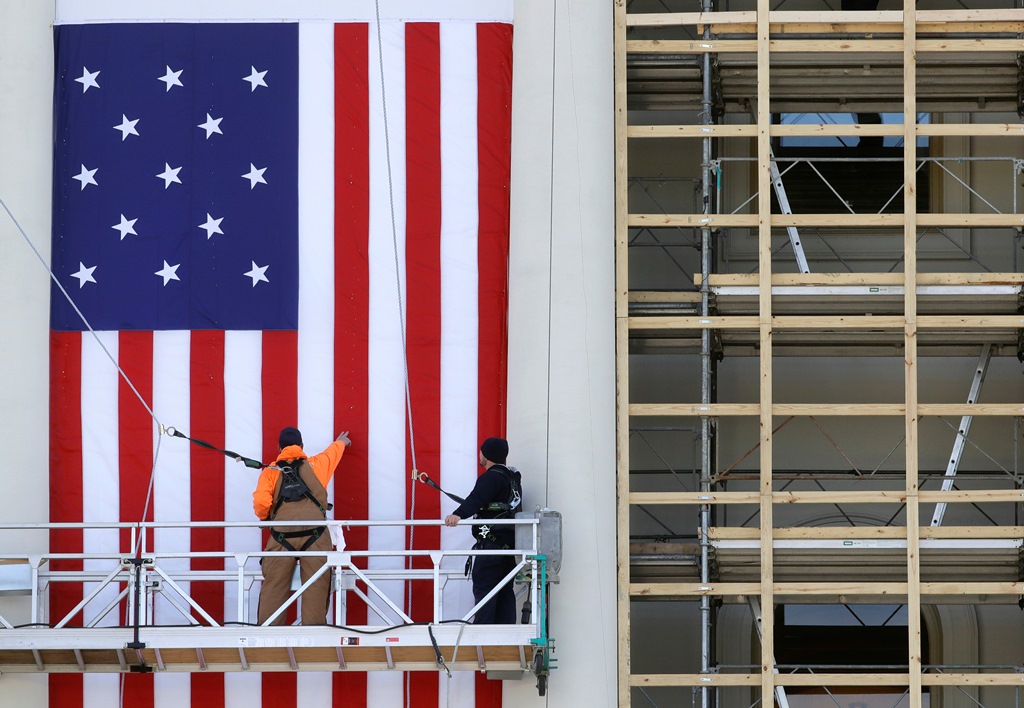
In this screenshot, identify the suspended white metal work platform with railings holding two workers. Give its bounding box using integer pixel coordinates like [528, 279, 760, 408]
[0, 510, 560, 691]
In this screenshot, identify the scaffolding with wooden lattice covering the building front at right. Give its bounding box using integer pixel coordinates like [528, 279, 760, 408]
[615, 0, 1024, 708]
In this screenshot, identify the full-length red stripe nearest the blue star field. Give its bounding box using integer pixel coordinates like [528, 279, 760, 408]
[333, 24, 370, 706]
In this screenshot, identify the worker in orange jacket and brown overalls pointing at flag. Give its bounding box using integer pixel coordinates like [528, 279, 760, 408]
[253, 427, 352, 625]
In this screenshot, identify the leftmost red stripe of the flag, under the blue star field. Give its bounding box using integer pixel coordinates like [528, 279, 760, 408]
[49, 332, 83, 708]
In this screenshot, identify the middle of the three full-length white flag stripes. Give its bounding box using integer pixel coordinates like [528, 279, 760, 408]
[367, 23, 407, 707]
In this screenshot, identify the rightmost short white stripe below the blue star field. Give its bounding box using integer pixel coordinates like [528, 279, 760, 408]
[224, 332, 263, 708]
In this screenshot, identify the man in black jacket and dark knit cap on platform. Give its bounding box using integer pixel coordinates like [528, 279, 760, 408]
[444, 438, 522, 624]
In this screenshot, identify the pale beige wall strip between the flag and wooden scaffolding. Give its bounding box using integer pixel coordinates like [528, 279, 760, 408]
[505, 0, 616, 706]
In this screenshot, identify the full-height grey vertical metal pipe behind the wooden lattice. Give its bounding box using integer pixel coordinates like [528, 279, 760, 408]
[700, 0, 714, 708]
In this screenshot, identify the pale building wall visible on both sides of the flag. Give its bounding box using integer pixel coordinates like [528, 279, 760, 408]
[0, 0, 615, 708]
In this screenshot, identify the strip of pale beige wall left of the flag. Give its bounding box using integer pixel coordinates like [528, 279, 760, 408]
[0, 0, 53, 708]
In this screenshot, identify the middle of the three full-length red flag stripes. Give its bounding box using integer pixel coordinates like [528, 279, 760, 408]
[406, 23, 441, 708]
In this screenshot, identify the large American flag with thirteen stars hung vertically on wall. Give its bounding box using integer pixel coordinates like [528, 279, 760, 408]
[50, 0, 512, 708]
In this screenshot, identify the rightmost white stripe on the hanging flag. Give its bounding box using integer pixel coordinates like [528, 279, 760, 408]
[438, 25, 477, 706]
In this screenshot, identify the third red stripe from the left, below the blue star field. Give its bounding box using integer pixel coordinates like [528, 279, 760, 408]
[188, 331, 225, 708]
